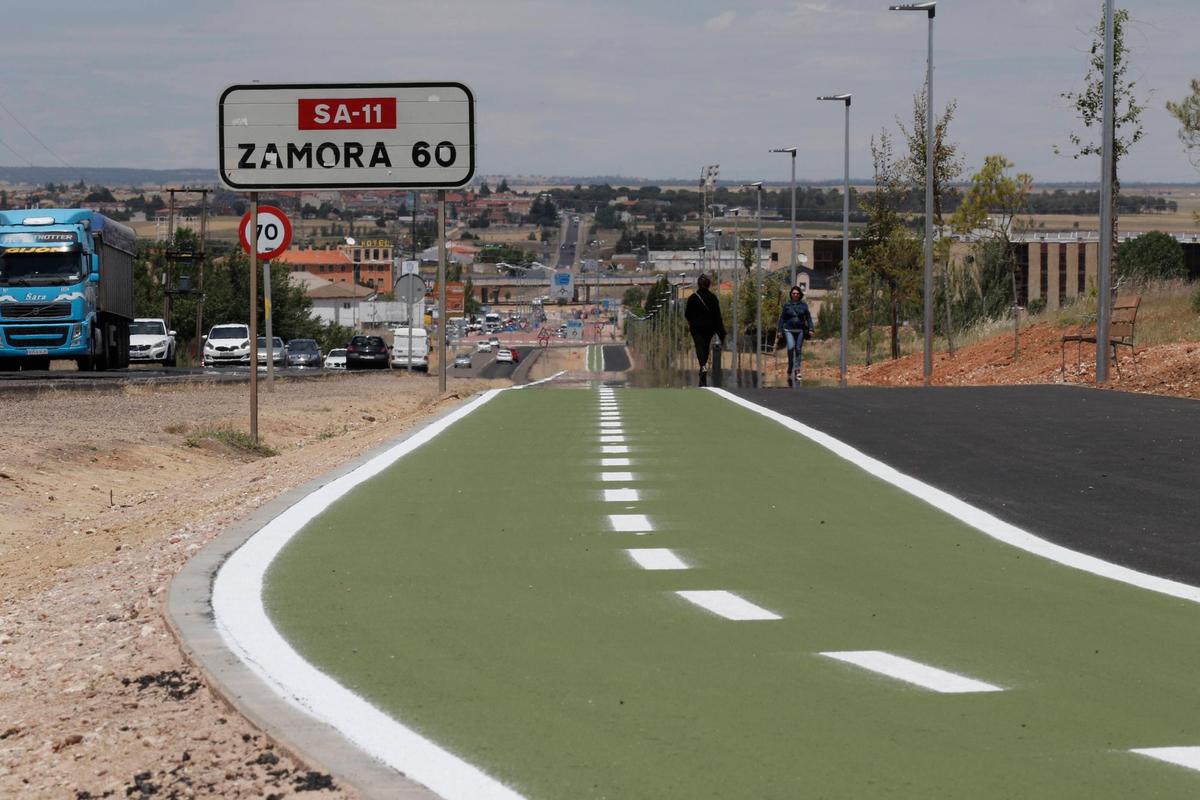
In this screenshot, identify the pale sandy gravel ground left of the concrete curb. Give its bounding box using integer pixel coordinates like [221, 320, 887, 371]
[0, 374, 491, 800]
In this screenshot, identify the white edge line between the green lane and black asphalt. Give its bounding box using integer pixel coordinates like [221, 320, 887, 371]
[708, 389, 1200, 603]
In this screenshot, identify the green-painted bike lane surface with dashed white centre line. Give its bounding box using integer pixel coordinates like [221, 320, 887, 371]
[265, 390, 1200, 799]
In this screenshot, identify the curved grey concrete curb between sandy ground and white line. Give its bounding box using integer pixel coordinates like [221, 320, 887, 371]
[163, 392, 484, 800]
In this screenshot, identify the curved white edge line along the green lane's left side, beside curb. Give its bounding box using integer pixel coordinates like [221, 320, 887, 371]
[212, 384, 532, 800]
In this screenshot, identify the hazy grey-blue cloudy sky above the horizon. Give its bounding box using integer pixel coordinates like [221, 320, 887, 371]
[0, 0, 1200, 182]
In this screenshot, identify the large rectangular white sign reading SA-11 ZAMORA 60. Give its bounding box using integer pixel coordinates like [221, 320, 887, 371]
[218, 83, 475, 191]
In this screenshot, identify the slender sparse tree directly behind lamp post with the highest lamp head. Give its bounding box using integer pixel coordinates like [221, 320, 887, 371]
[896, 88, 962, 357]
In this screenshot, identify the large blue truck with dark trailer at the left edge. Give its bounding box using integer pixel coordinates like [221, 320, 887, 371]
[0, 209, 137, 369]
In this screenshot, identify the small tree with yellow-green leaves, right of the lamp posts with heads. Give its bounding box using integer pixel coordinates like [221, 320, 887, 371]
[950, 155, 1033, 361]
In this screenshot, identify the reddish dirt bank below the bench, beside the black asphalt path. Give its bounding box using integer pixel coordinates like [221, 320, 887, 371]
[782, 324, 1200, 398]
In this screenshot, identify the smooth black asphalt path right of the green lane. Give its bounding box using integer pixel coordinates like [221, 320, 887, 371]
[738, 386, 1200, 584]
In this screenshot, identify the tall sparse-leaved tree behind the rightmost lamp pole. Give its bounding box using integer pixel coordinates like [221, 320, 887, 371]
[1055, 8, 1146, 245]
